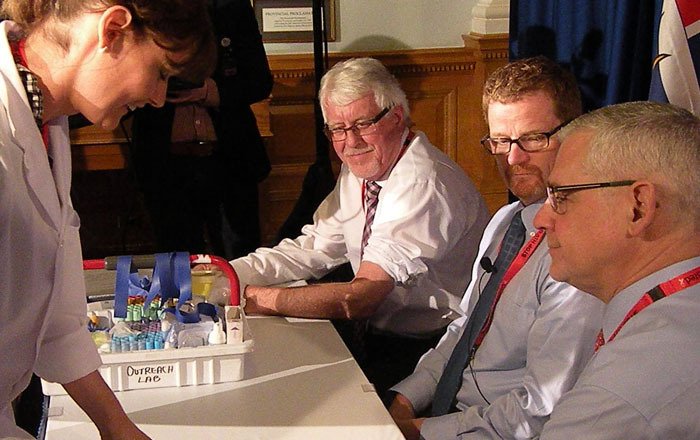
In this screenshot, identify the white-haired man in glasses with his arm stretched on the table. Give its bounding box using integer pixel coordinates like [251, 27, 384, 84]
[232, 58, 488, 395]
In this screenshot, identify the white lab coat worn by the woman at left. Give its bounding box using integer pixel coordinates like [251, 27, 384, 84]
[0, 21, 100, 437]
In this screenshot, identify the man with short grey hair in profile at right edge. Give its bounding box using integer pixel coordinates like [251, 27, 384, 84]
[535, 102, 700, 440]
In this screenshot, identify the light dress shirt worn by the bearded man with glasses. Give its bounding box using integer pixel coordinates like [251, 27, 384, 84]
[392, 202, 603, 440]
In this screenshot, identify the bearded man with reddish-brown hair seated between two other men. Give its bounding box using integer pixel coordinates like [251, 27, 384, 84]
[390, 57, 602, 440]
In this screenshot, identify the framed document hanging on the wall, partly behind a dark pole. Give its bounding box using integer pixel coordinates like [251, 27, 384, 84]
[253, 0, 336, 43]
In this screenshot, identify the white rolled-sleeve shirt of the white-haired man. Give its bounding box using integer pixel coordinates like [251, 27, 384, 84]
[232, 132, 488, 336]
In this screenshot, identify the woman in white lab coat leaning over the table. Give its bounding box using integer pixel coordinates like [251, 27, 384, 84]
[0, 0, 215, 439]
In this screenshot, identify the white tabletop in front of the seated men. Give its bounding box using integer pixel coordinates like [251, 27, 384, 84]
[46, 317, 404, 440]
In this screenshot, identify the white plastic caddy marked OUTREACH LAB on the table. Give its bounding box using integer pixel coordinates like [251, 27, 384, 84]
[42, 255, 253, 396]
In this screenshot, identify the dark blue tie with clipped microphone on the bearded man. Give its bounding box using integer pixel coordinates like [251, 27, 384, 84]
[432, 211, 525, 417]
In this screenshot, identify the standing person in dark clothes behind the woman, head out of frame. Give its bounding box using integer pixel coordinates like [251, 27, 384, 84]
[132, 0, 272, 259]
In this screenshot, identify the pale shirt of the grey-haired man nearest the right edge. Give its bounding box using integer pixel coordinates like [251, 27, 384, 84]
[541, 257, 700, 440]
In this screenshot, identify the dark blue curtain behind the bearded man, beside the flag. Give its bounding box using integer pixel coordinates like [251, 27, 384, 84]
[510, 0, 662, 110]
